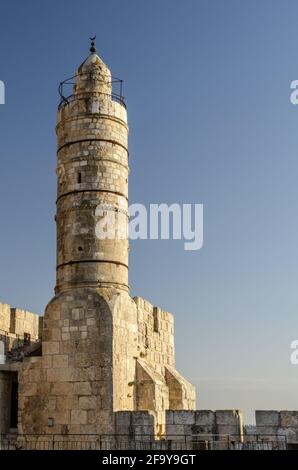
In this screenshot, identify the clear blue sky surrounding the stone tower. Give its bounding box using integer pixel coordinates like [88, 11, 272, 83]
[0, 0, 298, 421]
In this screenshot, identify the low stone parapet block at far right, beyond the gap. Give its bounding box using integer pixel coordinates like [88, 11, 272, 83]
[256, 410, 298, 444]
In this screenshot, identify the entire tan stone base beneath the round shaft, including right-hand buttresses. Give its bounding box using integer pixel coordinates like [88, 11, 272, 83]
[19, 288, 195, 434]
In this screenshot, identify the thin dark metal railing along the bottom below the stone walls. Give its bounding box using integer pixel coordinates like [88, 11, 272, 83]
[0, 434, 287, 451]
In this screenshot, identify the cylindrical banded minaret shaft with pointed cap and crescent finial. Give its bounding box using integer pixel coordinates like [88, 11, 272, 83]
[56, 41, 128, 293]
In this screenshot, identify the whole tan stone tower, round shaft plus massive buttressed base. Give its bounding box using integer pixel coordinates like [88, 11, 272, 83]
[19, 43, 195, 434]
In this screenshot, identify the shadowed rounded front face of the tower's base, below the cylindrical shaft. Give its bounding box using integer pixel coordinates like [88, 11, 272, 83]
[19, 288, 114, 434]
